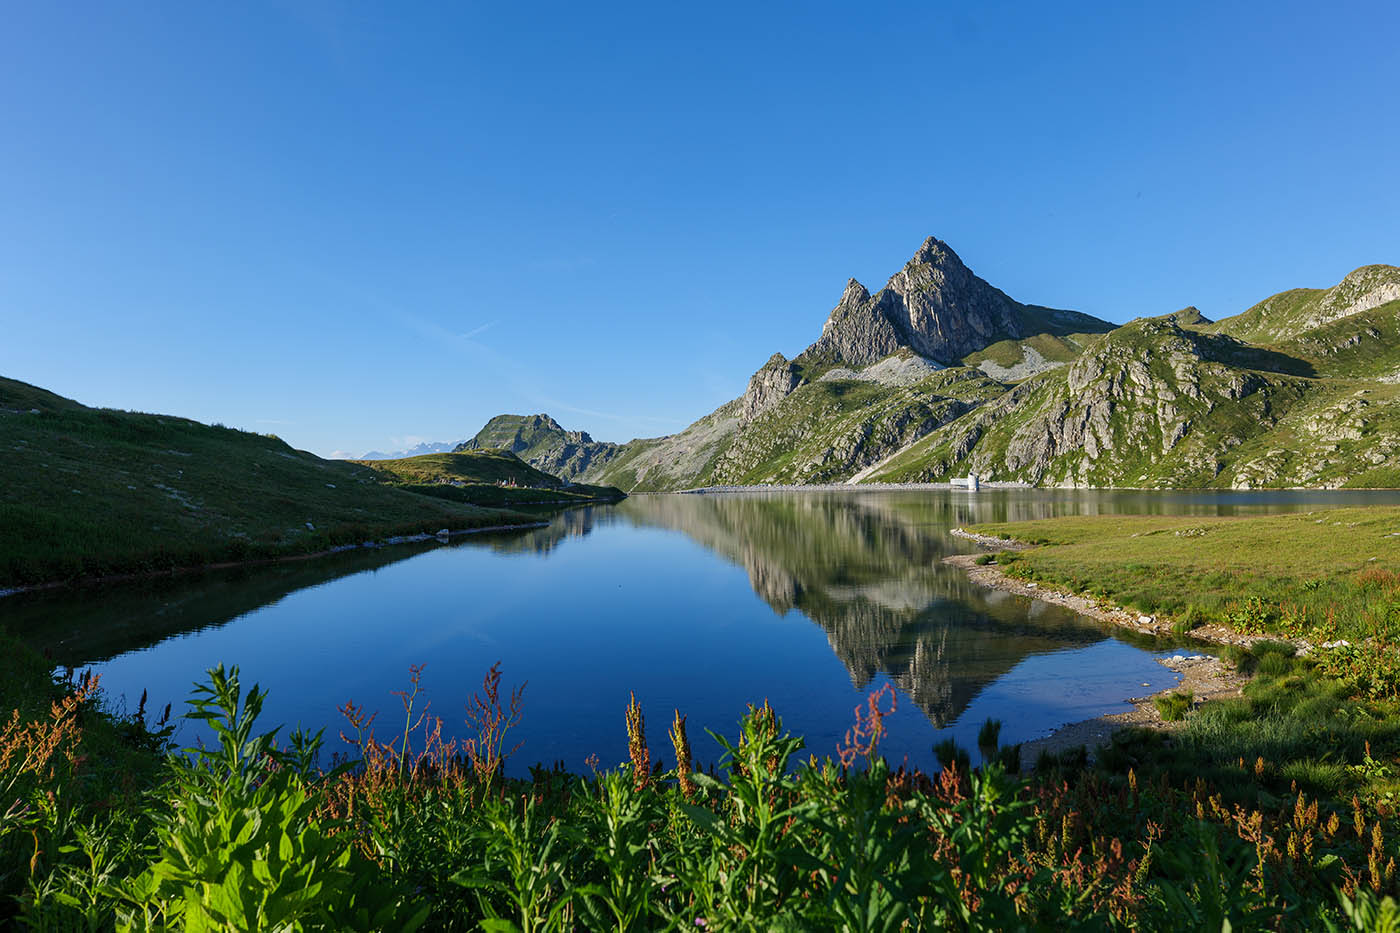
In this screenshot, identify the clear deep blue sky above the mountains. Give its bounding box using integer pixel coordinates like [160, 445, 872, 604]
[0, 1, 1400, 455]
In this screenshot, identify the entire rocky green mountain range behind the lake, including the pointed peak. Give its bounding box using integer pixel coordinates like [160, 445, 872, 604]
[458, 238, 1400, 490]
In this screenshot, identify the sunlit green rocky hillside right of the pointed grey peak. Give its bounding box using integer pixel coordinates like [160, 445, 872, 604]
[868, 308, 1400, 488]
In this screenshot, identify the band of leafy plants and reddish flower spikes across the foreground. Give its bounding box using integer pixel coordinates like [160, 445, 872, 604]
[0, 622, 1400, 930]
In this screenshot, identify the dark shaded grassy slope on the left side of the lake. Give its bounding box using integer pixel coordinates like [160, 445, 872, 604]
[0, 378, 528, 587]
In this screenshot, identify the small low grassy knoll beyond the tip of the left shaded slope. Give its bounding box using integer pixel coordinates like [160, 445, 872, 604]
[350, 448, 623, 507]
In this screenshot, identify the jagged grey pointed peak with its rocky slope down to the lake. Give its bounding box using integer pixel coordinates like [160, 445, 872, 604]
[582, 237, 1112, 490]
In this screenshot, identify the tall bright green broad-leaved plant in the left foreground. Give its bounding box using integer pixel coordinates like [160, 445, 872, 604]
[116, 665, 427, 930]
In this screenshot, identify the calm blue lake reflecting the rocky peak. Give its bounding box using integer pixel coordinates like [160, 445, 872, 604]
[10, 489, 1400, 773]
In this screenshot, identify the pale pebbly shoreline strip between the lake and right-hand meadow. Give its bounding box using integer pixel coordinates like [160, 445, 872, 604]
[942, 528, 1282, 770]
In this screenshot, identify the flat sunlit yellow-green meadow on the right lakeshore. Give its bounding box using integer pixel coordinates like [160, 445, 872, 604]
[970, 506, 1400, 639]
